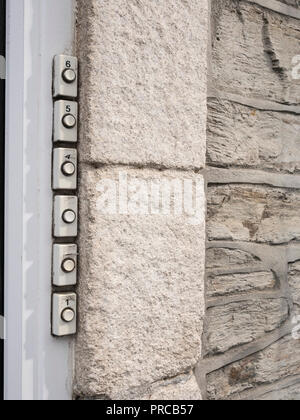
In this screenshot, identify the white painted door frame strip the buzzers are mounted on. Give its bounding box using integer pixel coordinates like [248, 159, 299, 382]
[4, 0, 75, 400]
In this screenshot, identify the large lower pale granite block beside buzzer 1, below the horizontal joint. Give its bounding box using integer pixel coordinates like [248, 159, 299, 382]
[74, 165, 205, 399]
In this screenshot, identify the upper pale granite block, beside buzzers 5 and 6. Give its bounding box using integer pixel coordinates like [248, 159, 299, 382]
[77, 0, 208, 168]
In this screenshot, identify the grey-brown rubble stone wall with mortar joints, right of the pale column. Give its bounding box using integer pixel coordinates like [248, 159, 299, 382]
[197, 0, 300, 400]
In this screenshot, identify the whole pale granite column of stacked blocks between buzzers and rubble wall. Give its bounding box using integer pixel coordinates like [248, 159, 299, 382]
[74, 0, 208, 399]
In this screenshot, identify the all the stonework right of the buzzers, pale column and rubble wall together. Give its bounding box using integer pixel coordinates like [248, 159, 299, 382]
[74, 0, 300, 400]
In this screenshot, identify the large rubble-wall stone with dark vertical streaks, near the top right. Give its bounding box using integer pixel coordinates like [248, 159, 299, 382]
[211, 0, 300, 104]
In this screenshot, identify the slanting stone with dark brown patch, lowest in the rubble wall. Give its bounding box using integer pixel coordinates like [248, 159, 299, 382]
[208, 336, 300, 400]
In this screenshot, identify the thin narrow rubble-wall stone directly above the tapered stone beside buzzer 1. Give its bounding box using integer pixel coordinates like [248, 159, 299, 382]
[206, 271, 276, 298]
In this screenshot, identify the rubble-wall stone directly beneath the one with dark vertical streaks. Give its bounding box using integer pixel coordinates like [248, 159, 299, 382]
[207, 97, 300, 172]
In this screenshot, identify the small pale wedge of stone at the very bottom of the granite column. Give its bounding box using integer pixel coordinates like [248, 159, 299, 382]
[143, 373, 202, 401]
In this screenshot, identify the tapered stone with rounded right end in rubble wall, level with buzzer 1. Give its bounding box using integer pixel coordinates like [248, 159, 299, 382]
[205, 299, 288, 354]
